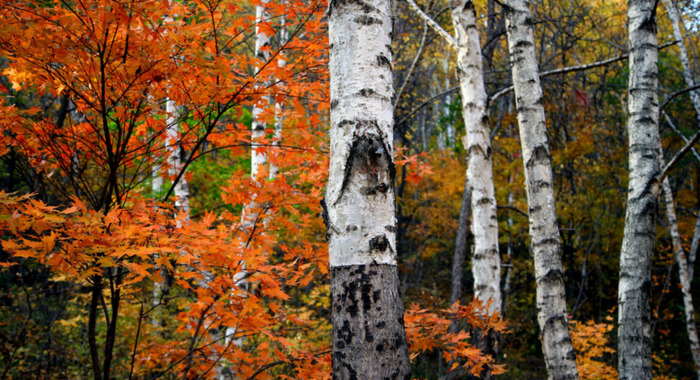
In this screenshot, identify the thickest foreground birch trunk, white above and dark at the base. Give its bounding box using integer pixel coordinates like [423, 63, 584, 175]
[324, 0, 411, 379]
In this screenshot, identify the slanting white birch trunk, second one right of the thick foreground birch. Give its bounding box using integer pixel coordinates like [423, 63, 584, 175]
[504, 0, 578, 379]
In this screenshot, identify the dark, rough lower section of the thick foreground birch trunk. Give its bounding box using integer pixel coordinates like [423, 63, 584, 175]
[331, 264, 411, 379]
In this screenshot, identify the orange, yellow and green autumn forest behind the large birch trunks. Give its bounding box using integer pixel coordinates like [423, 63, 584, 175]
[0, 0, 700, 379]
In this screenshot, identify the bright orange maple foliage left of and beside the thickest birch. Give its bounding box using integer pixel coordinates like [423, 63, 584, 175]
[0, 0, 503, 379]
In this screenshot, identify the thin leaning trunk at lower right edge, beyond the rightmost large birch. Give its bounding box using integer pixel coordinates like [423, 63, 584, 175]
[663, 177, 700, 380]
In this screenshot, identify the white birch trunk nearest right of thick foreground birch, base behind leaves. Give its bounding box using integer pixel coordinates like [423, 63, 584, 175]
[452, 0, 501, 314]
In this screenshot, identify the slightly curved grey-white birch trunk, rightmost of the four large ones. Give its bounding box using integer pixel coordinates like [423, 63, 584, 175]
[618, 0, 661, 380]
